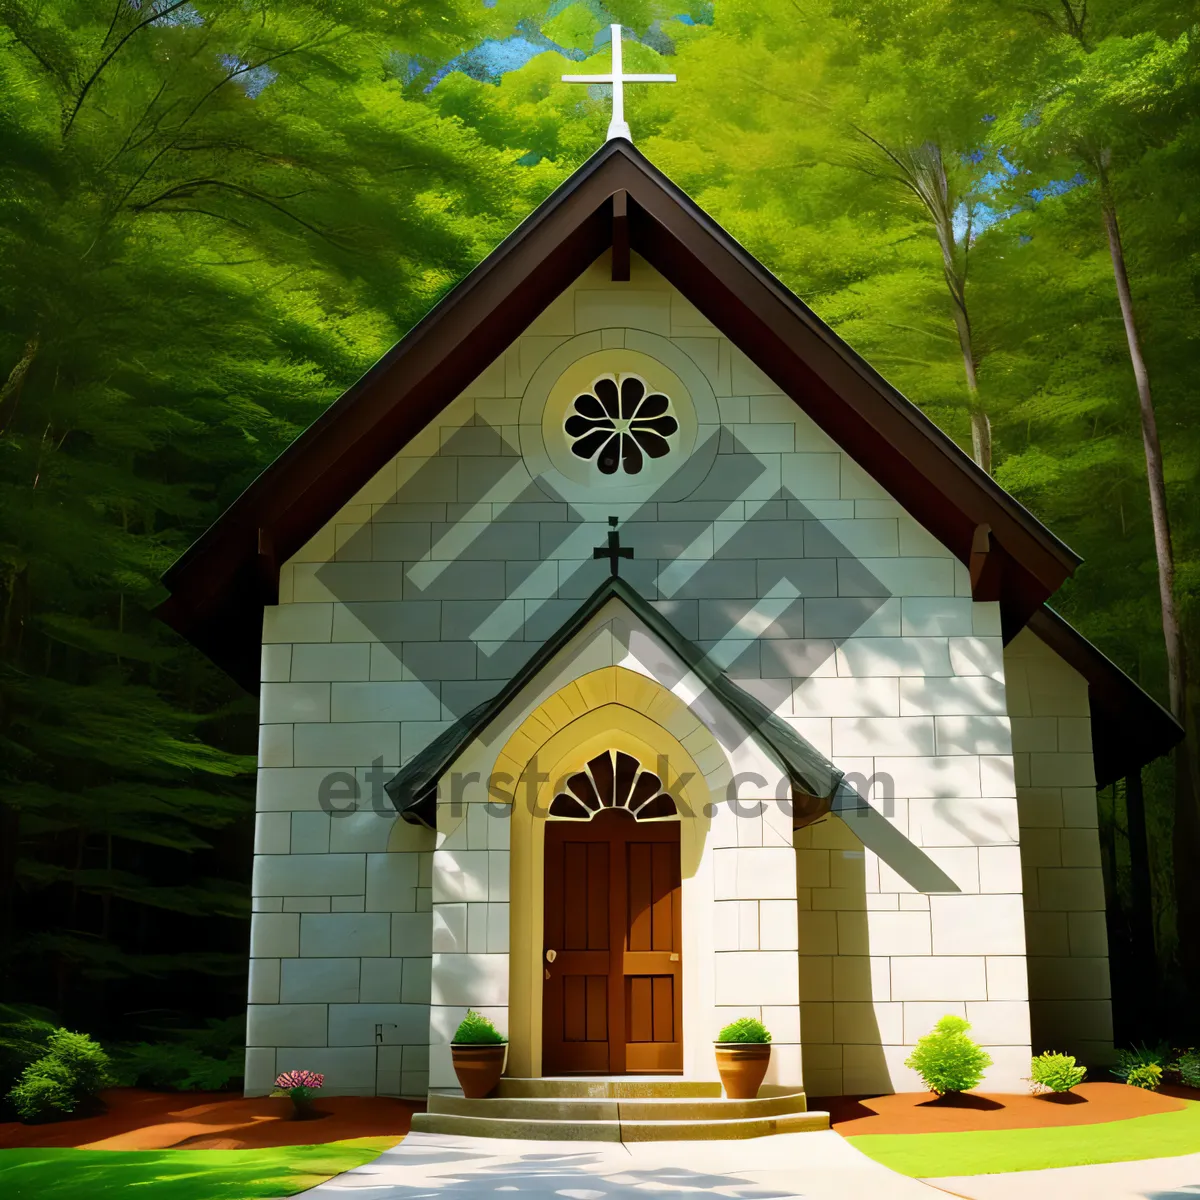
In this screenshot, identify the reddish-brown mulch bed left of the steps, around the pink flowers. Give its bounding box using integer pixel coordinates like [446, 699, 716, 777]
[0, 1087, 425, 1150]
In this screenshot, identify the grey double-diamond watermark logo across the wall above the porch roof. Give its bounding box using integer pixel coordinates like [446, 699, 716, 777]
[309, 418, 899, 734]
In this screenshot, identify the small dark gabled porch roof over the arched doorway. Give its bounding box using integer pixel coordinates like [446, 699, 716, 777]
[384, 577, 845, 829]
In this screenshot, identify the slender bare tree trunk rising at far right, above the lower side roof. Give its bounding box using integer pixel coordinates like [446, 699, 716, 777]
[1100, 167, 1187, 722]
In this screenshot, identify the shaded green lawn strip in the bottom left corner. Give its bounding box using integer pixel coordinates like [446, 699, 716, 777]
[0, 1138, 395, 1200]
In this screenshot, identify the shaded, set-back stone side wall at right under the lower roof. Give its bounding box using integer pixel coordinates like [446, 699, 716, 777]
[1004, 629, 1112, 1063]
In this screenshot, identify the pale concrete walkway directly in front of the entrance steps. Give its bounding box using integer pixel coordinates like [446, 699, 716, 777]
[301, 1130, 940, 1200]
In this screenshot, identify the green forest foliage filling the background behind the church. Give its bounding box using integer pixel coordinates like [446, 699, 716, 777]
[0, 0, 1200, 1046]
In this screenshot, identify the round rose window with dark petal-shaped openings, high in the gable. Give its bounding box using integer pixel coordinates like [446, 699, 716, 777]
[565, 376, 679, 475]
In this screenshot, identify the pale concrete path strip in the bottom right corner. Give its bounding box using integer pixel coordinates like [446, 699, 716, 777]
[926, 1152, 1200, 1200]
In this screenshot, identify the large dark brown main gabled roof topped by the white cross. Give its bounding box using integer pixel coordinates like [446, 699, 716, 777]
[158, 139, 1079, 690]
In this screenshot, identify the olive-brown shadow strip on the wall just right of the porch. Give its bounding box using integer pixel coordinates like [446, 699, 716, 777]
[796, 811, 893, 1096]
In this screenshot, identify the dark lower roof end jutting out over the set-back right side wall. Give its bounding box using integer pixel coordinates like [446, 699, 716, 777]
[1030, 605, 1183, 787]
